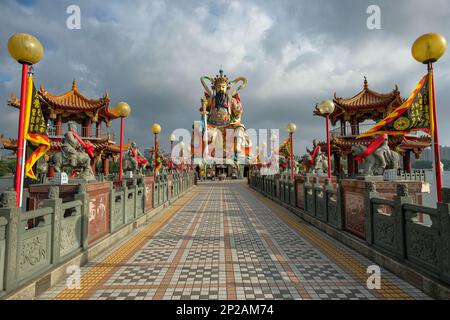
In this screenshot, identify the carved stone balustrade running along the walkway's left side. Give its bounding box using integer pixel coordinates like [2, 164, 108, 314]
[0, 172, 194, 296]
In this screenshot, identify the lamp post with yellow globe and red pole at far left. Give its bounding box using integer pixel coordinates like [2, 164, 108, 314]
[8, 33, 44, 207]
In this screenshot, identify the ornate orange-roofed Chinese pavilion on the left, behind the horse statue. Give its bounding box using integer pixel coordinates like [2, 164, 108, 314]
[0, 80, 128, 175]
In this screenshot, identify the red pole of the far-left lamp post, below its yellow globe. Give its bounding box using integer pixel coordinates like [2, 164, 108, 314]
[15, 63, 28, 207]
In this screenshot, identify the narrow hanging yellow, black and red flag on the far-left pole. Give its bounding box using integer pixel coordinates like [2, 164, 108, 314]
[24, 75, 50, 180]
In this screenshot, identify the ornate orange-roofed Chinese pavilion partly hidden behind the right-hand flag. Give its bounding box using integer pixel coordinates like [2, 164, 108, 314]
[313, 77, 431, 175]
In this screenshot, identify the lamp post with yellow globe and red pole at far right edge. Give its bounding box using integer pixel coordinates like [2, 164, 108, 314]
[411, 33, 447, 202]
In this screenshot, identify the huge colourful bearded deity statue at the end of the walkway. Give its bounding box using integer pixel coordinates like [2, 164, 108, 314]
[200, 70, 249, 161]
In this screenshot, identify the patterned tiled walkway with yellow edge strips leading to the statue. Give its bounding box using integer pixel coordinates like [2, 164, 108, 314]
[39, 181, 427, 300]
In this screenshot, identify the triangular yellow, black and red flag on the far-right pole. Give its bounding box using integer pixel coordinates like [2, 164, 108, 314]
[357, 73, 434, 138]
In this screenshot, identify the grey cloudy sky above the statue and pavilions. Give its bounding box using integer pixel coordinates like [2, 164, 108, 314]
[0, 0, 450, 153]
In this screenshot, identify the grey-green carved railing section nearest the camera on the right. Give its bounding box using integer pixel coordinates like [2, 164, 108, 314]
[367, 185, 450, 284]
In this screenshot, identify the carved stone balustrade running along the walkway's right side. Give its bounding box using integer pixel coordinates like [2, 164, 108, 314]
[250, 174, 450, 285]
